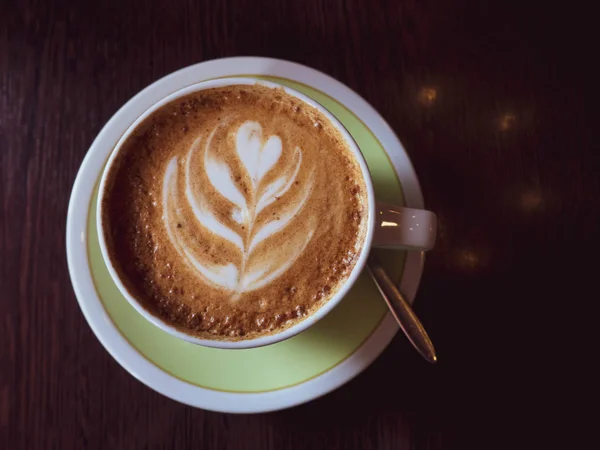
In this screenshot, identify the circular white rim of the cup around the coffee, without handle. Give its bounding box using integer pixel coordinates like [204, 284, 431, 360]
[96, 77, 375, 349]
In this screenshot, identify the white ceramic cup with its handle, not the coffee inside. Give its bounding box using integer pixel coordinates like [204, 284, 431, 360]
[96, 78, 437, 349]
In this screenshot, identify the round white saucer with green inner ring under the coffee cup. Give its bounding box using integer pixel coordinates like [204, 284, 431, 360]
[67, 57, 423, 413]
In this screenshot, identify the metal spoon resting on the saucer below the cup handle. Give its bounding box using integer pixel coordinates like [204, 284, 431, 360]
[367, 253, 437, 363]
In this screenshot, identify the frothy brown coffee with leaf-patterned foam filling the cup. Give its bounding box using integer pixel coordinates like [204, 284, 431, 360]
[101, 85, 368, 340]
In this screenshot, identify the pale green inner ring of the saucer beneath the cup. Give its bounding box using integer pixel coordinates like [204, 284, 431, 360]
[88, 75, 405, 393]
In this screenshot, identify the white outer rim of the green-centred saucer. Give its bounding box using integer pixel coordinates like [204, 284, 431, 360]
[66, 57, 423, 413]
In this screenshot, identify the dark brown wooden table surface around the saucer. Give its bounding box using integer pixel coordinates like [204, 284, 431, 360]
[0, 0, 600, 450]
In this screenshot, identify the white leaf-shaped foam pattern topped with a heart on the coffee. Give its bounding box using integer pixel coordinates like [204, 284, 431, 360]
[162, 121, 316, 300]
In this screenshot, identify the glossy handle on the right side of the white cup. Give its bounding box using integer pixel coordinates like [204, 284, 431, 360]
[373, 202, 437, 250]
